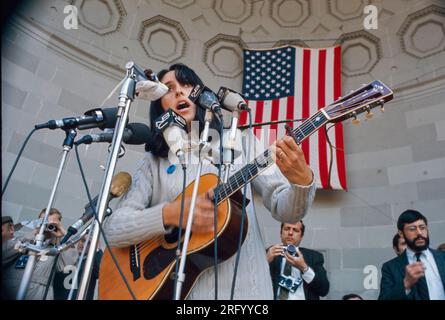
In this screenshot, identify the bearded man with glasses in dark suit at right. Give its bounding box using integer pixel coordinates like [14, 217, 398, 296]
[379, 210, 445, 300]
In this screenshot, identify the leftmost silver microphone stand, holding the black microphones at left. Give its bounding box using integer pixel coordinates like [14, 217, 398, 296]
[17, 129, 77, 300]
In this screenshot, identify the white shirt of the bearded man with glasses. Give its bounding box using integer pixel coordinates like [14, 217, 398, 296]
[406, 248, 445, 300]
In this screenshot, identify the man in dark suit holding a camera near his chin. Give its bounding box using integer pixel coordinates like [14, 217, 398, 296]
[267, 220, 329, 300]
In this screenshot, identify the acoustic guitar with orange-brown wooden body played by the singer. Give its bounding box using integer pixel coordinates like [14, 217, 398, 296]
[99, 80, 393, 300]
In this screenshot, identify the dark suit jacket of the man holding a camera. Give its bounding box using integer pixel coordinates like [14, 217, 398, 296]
[269, 248, 329, 300]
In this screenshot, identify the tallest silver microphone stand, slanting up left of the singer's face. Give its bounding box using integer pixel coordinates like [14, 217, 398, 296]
[77, 61, 137, 300]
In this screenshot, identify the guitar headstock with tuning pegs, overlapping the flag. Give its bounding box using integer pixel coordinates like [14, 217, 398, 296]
[323, 80, 394, 122]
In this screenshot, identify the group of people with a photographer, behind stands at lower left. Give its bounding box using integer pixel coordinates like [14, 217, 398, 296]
[2, 208, 102, 300]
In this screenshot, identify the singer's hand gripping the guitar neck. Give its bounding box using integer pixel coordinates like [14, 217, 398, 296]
[271, 136, 313, 186]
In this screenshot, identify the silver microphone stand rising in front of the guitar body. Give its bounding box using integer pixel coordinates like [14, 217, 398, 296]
[175, 109, 213, 300]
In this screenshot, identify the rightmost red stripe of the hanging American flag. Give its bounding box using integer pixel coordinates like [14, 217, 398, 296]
[334, 46, 346, 190]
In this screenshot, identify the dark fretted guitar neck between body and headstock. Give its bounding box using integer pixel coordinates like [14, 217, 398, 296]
[214, 109, 329, 204]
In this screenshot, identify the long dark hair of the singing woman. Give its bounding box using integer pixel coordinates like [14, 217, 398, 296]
[145, 63, 220, 158]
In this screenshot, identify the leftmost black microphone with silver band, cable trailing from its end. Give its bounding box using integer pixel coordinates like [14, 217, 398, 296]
[34, 107, 117, 130]
